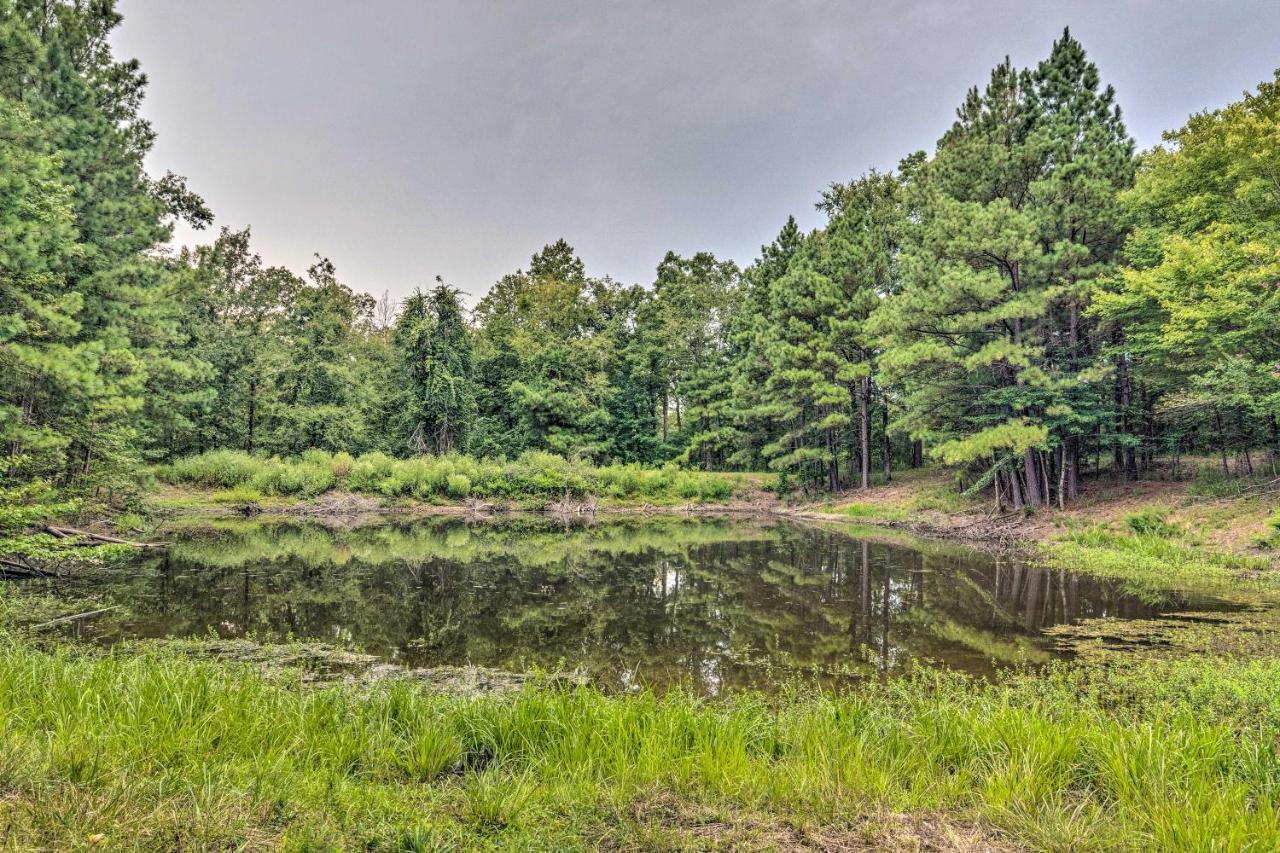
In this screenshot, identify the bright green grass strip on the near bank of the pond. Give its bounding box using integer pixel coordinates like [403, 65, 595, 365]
[0, 639, 1280, 850]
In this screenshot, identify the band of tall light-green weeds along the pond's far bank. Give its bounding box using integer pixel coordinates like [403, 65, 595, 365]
[157, 450, 736, 502]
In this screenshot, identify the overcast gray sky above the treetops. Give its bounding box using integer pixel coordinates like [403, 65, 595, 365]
[114, 0, 1280, 306]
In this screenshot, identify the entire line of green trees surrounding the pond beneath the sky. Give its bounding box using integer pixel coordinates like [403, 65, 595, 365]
[0, 0, 1280, 508]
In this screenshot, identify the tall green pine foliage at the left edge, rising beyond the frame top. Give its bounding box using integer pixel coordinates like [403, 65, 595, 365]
[0, 1, 209, 489]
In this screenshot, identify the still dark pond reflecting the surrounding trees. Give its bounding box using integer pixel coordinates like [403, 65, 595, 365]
[37, 516, 1215, 694]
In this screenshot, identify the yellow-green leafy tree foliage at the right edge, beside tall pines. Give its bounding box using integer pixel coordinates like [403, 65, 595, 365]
[1093, 69, 1280, 461]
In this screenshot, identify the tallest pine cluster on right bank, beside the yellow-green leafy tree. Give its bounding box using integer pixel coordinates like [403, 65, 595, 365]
[873, 33, 1133, 506]
